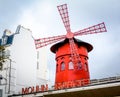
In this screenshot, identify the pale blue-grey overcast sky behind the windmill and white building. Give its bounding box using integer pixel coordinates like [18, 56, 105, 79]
[0, 0, 120, 82]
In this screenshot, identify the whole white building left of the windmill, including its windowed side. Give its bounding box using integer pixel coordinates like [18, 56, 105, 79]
[0, 26, 47, 97]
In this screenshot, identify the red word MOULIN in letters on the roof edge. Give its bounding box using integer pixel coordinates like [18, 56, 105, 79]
[22, 84, 48, 94]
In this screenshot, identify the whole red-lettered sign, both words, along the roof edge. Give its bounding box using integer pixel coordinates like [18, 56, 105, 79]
[22, 79, 90, 94]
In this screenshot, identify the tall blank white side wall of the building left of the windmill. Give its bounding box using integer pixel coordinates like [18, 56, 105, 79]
[10, 27, 37, 92]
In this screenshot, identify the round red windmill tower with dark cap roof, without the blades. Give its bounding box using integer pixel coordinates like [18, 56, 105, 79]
[51, 38, 93, 89]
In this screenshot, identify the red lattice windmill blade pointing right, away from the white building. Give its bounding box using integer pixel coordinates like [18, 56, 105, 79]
[74, 22, 107, 36]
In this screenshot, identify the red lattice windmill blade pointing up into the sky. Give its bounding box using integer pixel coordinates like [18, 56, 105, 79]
[57, 4, 71, 33]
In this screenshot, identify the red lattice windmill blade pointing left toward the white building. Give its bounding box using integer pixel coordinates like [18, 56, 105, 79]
[34, 35, 66, 49]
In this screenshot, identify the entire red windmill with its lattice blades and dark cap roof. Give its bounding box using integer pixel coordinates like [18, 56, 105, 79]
[35, 4, 107, 89]
